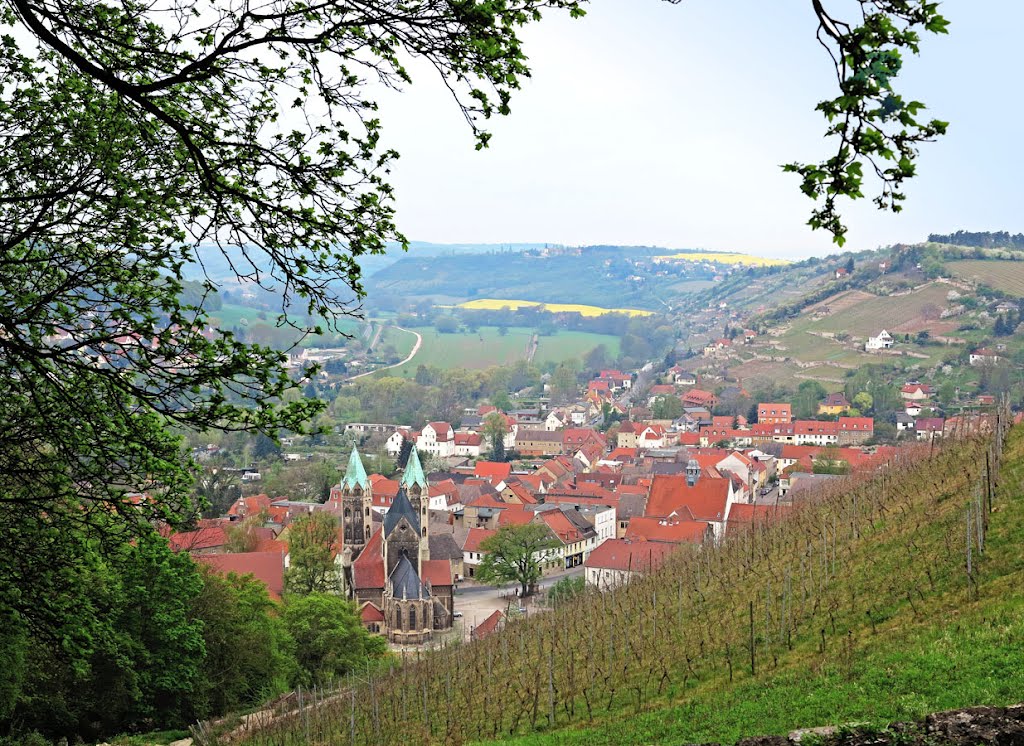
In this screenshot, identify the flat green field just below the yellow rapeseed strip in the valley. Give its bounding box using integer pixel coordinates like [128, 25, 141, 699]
[384, 326, 618, 378]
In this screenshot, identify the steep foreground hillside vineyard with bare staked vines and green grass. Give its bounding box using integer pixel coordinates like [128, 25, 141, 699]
[228, 415, 1024, 746]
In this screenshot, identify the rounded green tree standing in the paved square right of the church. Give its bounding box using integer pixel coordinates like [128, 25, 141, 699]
[476, 523, 559, 596]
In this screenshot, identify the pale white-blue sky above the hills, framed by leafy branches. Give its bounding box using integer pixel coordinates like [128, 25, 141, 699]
[379, 0, 1024, 259]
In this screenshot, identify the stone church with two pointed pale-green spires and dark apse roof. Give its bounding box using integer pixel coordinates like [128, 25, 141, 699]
[329, 448, 455, 645]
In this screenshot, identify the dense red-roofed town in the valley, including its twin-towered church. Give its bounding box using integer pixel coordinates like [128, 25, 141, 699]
[171, 358, 1007, 646]
